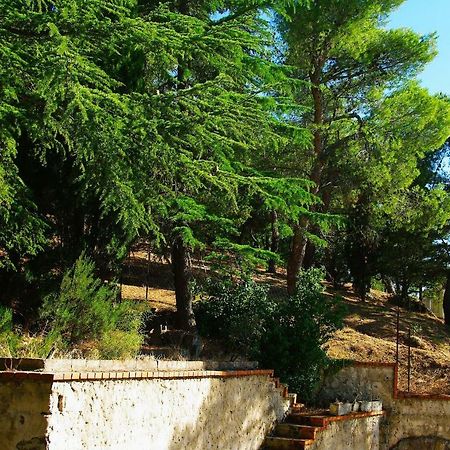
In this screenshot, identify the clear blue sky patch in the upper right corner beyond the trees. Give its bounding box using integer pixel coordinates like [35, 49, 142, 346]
[389, 0, 450, 95]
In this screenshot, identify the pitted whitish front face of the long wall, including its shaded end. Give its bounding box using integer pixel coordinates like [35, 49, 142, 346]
[48, 376, 285, 450]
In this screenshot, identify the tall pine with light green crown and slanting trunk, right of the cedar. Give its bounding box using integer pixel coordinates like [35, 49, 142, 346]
[280, 0, 448, 292]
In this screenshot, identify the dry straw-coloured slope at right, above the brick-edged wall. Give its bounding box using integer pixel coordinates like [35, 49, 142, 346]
[326, 288, 450, 394]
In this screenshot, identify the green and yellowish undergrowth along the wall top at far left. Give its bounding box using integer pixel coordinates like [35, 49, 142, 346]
[0, 254, 148, 359]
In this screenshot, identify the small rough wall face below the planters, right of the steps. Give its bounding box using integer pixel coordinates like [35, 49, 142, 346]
[308, 416, 383, 450]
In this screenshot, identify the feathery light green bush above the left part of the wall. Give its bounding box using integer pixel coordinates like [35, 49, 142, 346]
[41, 254, 142, 357]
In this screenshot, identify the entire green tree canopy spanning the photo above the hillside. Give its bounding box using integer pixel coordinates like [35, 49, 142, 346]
[0, 0, 450, 328]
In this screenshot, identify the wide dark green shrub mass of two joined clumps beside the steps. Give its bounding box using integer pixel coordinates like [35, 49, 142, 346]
[195, 269, 345, 401]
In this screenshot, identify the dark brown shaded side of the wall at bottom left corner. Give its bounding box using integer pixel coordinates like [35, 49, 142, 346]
[0, 380, 51, 450]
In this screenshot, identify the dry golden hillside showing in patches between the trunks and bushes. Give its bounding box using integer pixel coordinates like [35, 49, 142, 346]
[122, 252, 450, 394]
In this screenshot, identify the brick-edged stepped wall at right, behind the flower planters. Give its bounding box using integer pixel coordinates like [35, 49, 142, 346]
[319, 363, 450, 450]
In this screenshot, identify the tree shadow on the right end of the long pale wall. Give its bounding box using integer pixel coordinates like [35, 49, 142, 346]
[168, 378, 276, 450]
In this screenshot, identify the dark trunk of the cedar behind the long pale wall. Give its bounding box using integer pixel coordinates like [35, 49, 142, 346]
[172, 238, 195, 330]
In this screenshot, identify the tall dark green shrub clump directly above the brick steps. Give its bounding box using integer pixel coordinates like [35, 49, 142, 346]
[259, 269, 345, 402]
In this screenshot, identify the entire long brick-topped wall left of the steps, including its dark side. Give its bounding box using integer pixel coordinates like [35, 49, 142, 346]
[0, 361, 289, 450]
